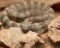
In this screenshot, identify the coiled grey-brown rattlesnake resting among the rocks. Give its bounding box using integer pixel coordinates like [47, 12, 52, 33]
[0, 1, 55, 33]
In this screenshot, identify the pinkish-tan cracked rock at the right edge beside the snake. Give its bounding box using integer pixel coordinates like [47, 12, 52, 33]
[48, 16, 60, 42]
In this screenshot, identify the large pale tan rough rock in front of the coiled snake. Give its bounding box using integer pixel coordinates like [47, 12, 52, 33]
[0, 27, 44, 48]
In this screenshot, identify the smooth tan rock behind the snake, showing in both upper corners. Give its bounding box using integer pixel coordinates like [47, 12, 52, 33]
[0, 0, 60, 8]
